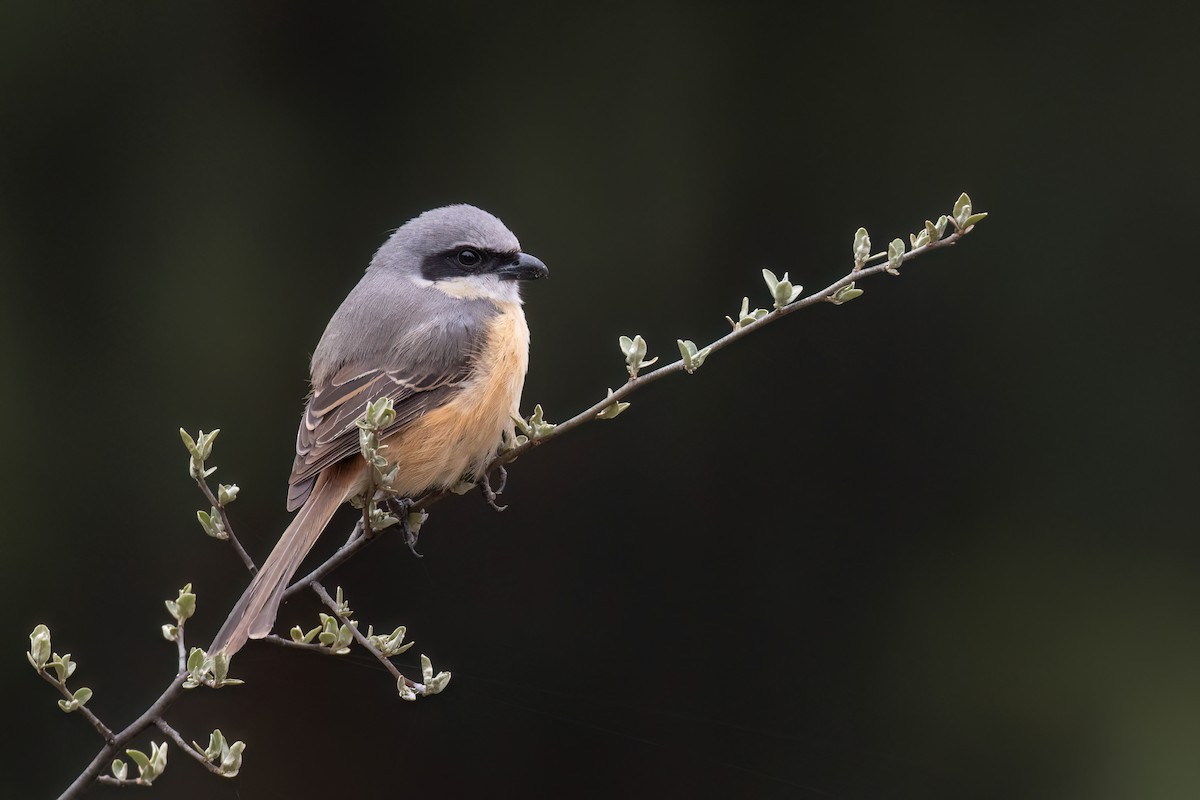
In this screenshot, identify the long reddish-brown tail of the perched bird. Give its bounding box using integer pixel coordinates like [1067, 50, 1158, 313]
[209, 469, 346, 656]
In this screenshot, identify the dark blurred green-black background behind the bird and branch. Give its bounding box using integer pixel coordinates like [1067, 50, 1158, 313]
[0, 2, 1200, 799]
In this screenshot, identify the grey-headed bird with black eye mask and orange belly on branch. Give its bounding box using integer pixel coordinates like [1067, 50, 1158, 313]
[210, 204, 550, 656]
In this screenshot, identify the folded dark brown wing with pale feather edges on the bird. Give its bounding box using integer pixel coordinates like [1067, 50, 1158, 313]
[288, 347, 476, 511]
